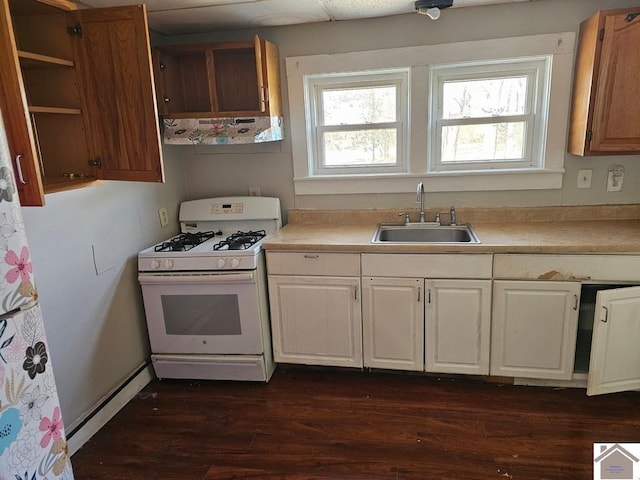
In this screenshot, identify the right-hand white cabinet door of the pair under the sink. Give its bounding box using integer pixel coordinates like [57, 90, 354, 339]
[425, 280, 491, 375]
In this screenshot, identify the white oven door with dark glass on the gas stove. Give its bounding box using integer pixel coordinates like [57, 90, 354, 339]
[140, 275, 266, 355]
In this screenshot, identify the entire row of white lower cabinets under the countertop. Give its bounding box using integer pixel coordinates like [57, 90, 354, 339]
[267, 251, 640, 395]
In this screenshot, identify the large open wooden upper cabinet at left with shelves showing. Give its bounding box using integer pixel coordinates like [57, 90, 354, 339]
[0, 0, 163, 205]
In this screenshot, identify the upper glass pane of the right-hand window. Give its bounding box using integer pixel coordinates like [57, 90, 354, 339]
[442, 76, 528, 119]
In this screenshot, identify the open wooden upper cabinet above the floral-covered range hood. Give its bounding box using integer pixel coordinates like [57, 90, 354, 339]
[153, 36, 282, 118]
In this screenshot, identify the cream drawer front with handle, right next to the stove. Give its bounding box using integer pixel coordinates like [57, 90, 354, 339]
[267, 252, 360, 277]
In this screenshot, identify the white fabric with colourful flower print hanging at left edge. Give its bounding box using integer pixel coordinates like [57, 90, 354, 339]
[0, 117, 73, 480]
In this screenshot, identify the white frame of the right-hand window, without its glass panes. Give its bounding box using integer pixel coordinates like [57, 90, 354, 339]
[427, 55, 552, 173]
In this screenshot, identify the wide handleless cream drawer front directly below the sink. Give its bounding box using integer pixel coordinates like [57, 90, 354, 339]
[362, 253, 493, 278]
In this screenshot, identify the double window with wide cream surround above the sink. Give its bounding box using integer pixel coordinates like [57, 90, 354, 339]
[286, 32, 576, 195]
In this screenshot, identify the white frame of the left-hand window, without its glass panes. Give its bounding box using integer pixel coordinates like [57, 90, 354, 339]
[304, 68, 409, 176]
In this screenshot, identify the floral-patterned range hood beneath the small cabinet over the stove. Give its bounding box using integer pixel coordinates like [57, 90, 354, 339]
[163, 117, 284, 145]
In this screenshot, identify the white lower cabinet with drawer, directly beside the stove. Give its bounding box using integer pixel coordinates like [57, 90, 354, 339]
[267, 252, 362, 367]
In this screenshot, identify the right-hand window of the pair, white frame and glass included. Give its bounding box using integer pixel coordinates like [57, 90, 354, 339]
[429, 56, 551, 172]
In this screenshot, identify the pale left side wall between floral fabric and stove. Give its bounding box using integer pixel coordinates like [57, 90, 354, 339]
[22, 143, 184, 433]
